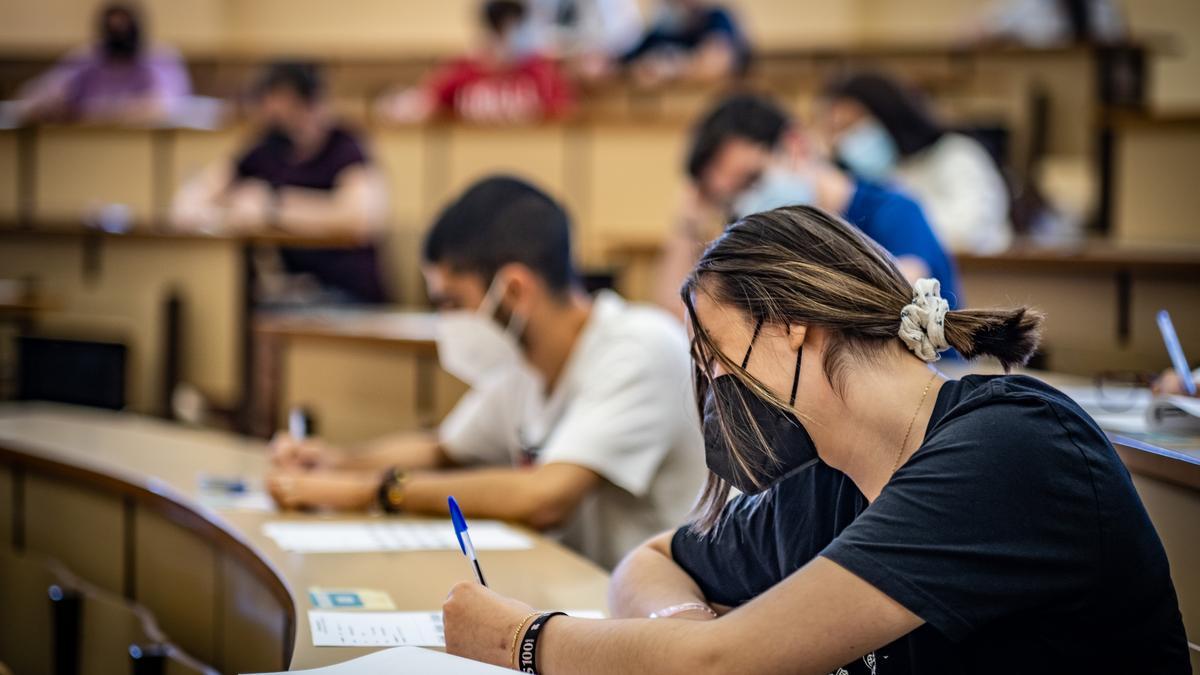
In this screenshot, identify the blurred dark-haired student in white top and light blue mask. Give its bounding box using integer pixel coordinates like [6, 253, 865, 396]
[822, 73, 1013, 253]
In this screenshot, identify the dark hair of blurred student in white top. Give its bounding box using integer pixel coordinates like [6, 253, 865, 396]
[826, 72, 946, 157]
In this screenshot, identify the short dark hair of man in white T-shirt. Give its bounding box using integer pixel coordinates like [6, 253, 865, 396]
[422, 175, 578, 293]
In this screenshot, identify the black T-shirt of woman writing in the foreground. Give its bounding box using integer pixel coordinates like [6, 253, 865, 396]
[672, 376, 1190, 675]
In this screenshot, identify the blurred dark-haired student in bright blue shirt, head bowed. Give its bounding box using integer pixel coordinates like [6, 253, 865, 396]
[655, 94, 961, 316]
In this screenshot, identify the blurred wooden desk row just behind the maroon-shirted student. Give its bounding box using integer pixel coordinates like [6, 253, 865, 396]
[0, 104, 1200, 281]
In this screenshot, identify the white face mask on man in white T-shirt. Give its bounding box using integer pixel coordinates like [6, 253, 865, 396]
[437, 280, 527, 387]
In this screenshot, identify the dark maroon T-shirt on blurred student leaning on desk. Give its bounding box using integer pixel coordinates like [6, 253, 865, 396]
[234, 127, 388, 303]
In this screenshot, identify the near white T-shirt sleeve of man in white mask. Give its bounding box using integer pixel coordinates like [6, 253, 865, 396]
[538, 331, 695, 497]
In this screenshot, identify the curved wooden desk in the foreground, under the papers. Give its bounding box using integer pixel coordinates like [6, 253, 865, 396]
[0, 404, 607, 673]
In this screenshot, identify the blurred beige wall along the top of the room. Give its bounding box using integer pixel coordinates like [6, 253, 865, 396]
[0, 0, 1200, 108]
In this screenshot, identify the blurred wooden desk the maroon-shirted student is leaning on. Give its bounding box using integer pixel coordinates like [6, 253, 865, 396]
[0, 221, 372, 419]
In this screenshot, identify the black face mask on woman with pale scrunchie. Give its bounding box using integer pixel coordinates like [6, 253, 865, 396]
[704, 321, 818, 495]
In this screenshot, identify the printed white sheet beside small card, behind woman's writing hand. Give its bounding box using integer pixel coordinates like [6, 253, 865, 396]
[308, 609, 604, 647]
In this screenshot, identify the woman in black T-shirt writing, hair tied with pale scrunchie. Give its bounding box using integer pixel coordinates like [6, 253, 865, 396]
[443, 207, 1190, 675]
